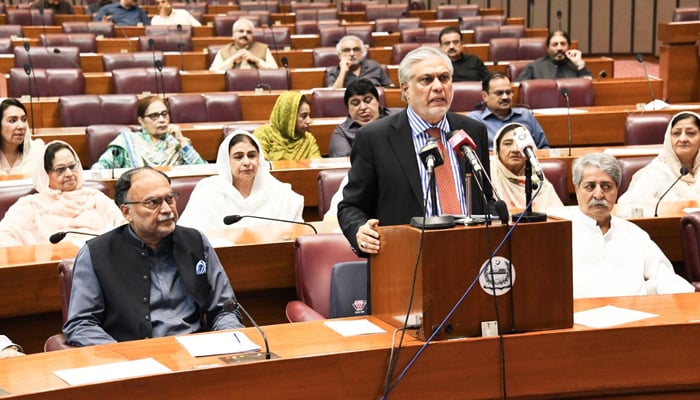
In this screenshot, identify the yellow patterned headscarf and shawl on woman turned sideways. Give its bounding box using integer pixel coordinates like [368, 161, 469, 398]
[253, 92, 321, 161]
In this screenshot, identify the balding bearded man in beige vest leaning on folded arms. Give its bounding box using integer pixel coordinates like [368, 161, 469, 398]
[209, 18, 277, 72]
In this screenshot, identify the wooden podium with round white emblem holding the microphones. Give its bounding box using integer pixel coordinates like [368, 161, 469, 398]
[370, 218, 573, 340]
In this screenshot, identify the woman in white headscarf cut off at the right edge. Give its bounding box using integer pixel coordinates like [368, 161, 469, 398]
[617, 111, 700, 217]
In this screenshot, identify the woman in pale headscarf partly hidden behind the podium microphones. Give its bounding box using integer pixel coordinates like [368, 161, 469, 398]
[491, 123, 564, 211]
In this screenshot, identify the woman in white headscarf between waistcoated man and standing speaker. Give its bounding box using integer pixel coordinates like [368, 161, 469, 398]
[178, 130, 304, 231]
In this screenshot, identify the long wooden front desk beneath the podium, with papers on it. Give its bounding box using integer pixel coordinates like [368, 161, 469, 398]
[0, 294, 700, 400]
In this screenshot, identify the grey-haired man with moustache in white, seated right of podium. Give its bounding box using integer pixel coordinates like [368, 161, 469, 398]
[561, 153, 694, 298]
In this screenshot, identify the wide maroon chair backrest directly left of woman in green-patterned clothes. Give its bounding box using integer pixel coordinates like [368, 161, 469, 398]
[58, 94, 138, 126]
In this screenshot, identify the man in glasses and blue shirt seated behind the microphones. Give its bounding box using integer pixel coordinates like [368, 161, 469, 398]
[467, 72, 549, 149]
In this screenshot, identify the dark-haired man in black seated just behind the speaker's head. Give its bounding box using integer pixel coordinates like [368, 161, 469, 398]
[438, 26, 489, 82]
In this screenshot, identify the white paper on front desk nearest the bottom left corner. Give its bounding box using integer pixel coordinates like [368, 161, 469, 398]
[53, 358, 170, 385]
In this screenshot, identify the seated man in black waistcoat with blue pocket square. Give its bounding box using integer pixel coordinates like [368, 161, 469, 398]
[63, 167, 243, 346]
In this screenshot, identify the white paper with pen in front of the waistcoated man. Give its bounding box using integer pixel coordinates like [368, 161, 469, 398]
[175, 331, 260, 357]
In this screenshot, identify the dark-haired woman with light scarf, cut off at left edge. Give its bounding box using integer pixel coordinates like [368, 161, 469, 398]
[0, 99, 44, 175]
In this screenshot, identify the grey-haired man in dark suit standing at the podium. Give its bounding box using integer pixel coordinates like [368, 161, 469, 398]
[338, 46, 491, 256]
